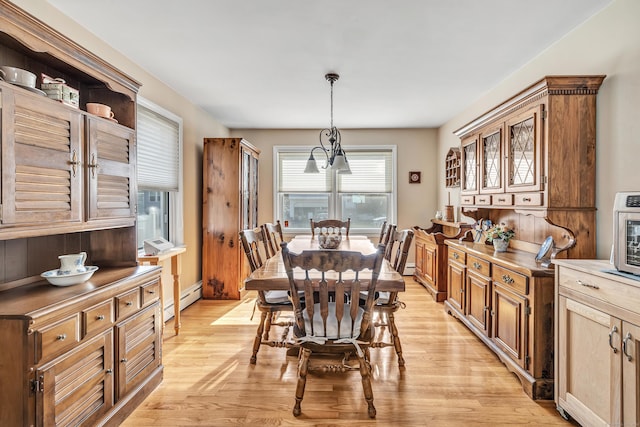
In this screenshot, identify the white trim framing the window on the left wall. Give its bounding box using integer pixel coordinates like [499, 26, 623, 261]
[137, 96, 184, 246]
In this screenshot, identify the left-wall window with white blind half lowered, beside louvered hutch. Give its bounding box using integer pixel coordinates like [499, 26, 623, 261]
[137, 97, 183, 249]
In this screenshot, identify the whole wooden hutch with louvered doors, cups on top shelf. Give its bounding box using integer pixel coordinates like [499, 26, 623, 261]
[0, 0, 163, 426]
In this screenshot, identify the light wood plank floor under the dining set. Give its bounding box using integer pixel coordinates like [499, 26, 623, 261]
[123, 277, 572, 427]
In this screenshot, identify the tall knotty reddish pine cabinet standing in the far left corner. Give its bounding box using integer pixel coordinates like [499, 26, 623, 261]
[202, 138, 260, 299]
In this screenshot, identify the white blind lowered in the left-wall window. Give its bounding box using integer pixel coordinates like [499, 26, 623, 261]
[137, 104, 180, 192]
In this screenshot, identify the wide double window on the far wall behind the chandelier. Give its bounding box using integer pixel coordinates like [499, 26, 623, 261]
[274, 146, 396, 233]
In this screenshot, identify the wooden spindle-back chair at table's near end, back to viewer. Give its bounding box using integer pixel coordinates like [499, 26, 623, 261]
[282, 243, 384, 418]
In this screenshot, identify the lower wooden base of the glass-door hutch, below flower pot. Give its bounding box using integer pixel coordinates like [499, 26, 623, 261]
[444, 241, 554, 399]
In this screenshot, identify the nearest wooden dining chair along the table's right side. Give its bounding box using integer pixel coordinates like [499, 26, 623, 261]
[368, 226, 414, 367]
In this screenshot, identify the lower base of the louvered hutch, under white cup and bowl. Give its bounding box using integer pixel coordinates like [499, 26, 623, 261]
[0, 266, 163, 427]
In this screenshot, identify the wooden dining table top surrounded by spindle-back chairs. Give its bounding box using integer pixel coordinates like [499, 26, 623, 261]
[244, 234, 405, 292]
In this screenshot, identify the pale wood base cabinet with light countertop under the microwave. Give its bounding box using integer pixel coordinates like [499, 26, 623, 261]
[555, 260, 640, 427]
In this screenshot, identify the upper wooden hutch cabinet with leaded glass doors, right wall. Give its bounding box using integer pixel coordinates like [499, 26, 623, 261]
[455, 76, 604, 258]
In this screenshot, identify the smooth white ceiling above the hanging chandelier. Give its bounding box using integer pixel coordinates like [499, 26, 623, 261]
[49, 0, 612, 128]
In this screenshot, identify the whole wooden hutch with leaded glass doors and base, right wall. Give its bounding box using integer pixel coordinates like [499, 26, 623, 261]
[445, 76, 604, 399]
